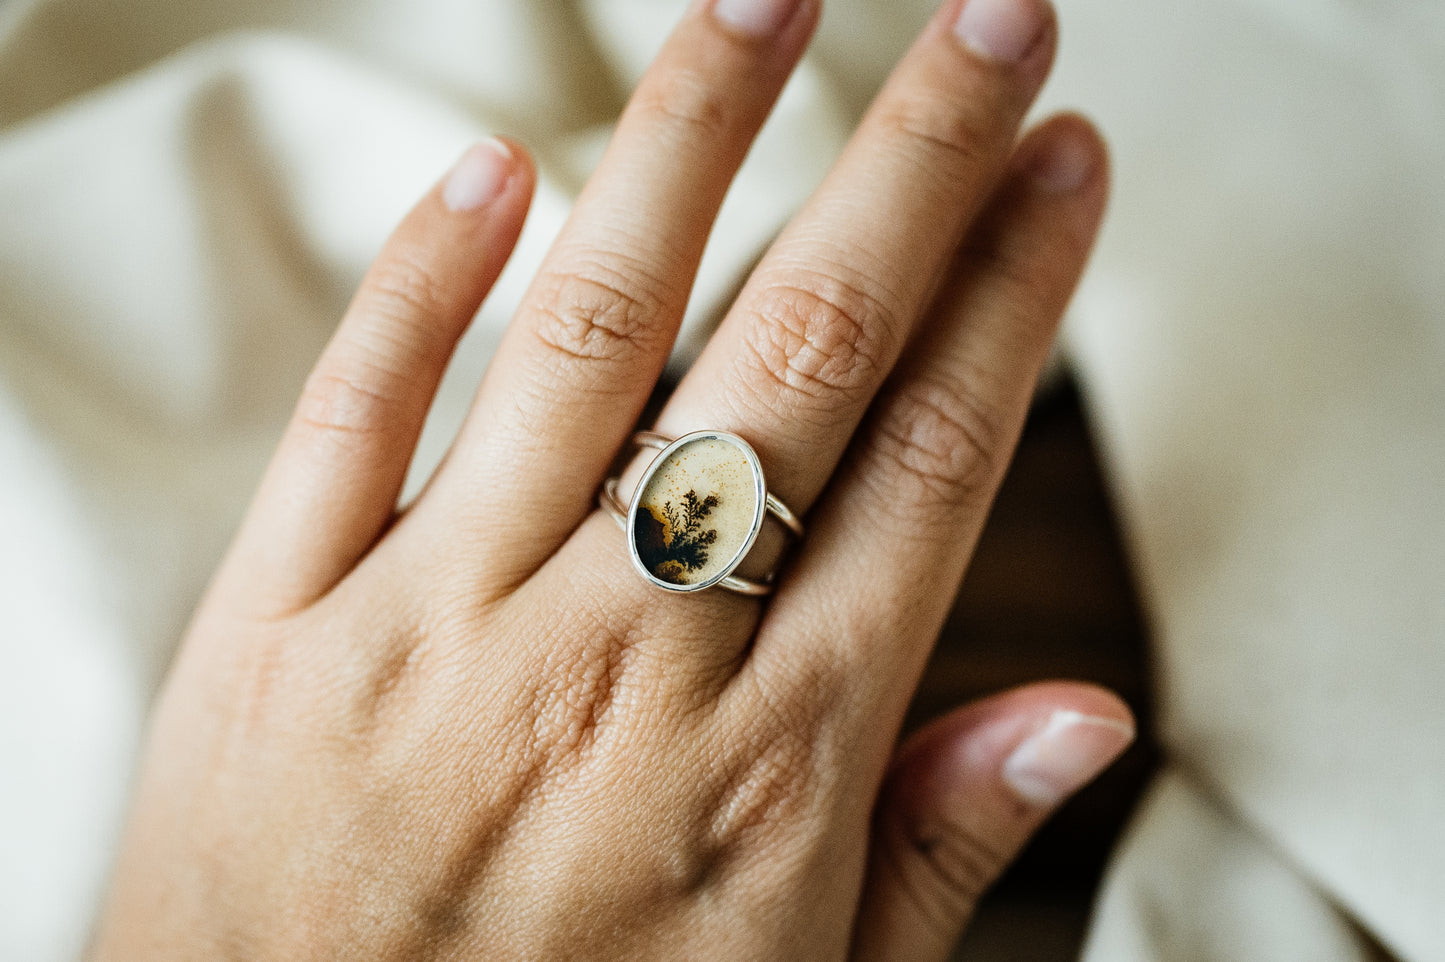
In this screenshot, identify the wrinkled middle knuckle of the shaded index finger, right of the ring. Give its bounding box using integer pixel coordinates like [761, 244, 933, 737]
[866, 378, 1007, 524]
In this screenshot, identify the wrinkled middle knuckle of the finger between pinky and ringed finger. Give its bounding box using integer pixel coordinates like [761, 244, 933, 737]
[535, 274, 660, 364]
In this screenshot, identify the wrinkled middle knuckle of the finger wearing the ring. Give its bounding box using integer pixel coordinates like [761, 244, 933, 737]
[747, 276, 897, 397]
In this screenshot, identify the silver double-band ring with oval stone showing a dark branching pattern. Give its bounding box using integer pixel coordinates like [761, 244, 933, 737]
[597, 430, 803, 597]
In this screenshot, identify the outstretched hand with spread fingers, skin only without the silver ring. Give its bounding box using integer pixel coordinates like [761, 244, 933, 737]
[94, 0, 1131, 962]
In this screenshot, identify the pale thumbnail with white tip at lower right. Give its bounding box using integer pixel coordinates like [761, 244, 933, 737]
[1003, 711, 1134, 809]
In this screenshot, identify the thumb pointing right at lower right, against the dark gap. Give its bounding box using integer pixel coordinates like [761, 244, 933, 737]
[853, 682, 1134, 962]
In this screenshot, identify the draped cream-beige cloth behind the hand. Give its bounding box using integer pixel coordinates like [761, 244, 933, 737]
[0, 0, 1445, 962]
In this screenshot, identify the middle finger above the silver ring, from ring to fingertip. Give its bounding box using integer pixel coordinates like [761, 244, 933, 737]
[657, 0, 1055, 511]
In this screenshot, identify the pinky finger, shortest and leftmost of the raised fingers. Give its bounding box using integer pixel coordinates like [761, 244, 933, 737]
[218, 140, 535, 617]
